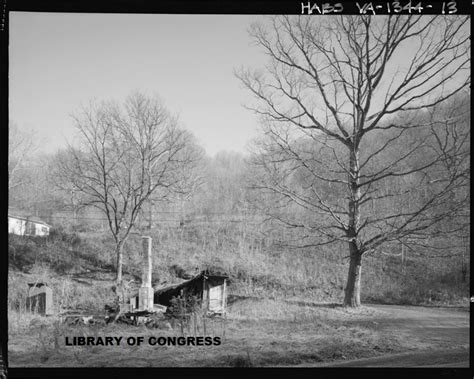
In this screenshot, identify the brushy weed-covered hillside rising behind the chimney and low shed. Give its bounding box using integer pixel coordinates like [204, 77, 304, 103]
[8, 223, 469, 311]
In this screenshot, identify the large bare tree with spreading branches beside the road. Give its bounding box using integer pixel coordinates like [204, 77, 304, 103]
[236, 16, 470, 306]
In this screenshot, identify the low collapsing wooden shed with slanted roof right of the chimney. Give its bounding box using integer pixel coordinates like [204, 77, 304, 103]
[154, 271, 228, 314]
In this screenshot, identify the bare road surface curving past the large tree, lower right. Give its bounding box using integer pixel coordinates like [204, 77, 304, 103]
[311, 305, 469, 367]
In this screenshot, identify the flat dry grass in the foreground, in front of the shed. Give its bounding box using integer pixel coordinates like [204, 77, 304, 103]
[9, 299, 401, 367]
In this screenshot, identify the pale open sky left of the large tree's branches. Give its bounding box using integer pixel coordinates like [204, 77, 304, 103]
[9, 12, 264, 155]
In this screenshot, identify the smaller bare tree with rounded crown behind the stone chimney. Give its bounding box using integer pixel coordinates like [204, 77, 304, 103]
[54, 93, 198, 284]
